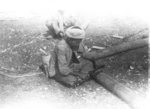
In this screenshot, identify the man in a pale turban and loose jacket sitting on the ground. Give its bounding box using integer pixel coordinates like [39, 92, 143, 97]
[39, 26, 93, 87]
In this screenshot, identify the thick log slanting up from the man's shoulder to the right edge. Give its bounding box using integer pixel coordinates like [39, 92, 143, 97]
[83, 38, 148, 60]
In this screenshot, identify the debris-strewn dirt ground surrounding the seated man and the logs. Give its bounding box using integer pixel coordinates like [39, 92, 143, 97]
[0, 11, 149, 109]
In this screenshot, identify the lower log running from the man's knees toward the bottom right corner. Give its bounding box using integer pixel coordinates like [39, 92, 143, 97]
[92, 73, 141, 109]
